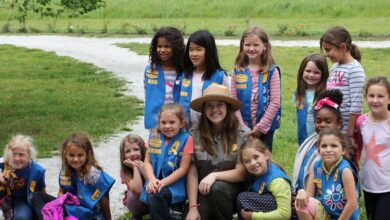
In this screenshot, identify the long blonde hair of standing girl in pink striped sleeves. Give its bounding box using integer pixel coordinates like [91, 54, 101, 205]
[236, 26, 275, 71]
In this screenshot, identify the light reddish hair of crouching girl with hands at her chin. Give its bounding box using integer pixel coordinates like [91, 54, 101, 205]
[119, 134, 146, 177]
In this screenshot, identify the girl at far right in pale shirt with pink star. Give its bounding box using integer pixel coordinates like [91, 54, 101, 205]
[357, 77, 390, 219]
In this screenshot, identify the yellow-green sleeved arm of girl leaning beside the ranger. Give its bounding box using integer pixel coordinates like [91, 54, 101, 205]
[252, 178, 291, 219]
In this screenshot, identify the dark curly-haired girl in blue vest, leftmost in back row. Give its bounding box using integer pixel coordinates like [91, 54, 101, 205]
[144, 27, 184, 129]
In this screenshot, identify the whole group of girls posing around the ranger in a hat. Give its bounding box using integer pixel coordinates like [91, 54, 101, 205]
[0, 23, 390, 220]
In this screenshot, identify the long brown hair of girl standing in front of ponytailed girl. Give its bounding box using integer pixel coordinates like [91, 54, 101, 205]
[295, 53, 329, 108]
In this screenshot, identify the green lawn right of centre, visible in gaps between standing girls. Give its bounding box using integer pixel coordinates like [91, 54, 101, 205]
[118, 42, 390, 219]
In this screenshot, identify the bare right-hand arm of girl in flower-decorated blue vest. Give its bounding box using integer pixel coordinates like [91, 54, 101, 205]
[339, 169, 359, 220]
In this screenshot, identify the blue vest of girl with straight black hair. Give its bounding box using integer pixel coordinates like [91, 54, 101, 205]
[179, 70, 226, 125]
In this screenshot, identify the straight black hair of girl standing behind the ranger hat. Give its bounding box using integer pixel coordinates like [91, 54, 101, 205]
[184, 30, 223, 80]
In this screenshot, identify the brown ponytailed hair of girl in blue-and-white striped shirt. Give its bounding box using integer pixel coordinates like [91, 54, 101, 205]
[320, 26, 362, 62]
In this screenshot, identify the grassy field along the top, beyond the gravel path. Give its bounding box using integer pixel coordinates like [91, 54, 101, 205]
[0, 0, 390, 39]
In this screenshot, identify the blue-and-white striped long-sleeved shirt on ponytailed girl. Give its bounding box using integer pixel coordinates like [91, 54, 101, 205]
[326, 60, 366, 133]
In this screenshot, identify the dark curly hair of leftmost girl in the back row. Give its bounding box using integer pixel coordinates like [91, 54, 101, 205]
[149, 27, 184, 74]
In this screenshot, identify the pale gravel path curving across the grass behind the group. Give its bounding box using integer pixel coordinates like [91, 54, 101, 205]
[0, 36, 390, 219]
